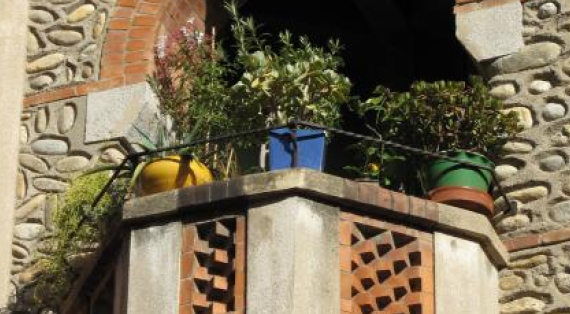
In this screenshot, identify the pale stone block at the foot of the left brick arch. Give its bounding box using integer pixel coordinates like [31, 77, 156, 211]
[85, 83, 158, 143]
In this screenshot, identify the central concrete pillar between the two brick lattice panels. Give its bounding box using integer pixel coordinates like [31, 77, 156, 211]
[246, 197, 340, 314]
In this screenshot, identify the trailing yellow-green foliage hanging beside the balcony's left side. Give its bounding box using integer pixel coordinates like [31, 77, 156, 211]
[34, 172, 126, 309]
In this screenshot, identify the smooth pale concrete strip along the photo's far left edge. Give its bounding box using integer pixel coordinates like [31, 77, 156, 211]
[0, 0, 28, 308]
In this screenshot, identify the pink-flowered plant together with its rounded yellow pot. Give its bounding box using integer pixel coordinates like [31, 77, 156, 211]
[140, 20, 237, 195]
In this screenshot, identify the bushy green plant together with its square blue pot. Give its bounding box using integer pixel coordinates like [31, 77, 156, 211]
[226, 3, 351, 170]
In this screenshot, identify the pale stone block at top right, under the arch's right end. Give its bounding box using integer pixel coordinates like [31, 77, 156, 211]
[456, 1, 524, 61]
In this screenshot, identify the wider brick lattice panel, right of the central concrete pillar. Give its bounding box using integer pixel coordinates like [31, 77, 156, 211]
[340, 213, 434, 314]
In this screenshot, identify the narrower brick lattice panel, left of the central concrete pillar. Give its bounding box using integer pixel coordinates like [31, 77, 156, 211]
[180, 217, 245, 314]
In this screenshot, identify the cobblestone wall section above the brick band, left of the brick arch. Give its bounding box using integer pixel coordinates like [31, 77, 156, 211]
[26, 0, 115, 93]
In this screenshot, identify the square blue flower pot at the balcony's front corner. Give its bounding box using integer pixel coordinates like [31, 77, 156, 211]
[269, 128, 325, 171]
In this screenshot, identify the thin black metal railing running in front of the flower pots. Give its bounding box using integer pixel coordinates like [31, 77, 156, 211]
[92, 121, 517, 215]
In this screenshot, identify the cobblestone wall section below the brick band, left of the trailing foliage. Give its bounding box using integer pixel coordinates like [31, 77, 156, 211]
[11, 97, 124, 313]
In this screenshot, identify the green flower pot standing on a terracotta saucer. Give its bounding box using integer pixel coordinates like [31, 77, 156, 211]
[427, 151, 494, 192]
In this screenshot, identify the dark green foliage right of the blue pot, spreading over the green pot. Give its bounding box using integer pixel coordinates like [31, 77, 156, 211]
[355, 77, 520, 194]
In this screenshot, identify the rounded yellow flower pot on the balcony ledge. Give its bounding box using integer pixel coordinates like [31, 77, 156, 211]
[137, 155, 214, 196]
